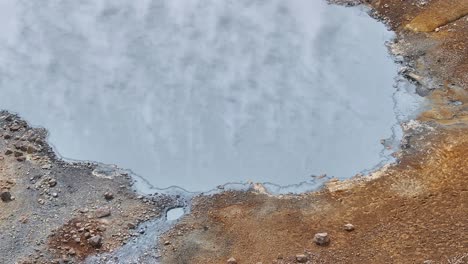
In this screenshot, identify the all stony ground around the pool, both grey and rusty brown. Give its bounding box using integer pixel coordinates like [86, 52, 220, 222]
[0, 0, 468, 263]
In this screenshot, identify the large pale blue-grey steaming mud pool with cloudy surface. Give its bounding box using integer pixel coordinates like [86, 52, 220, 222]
[0, 0, 420, 192]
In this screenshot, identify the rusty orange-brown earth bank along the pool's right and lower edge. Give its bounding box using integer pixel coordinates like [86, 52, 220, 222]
[161, 0, 468, 264]
